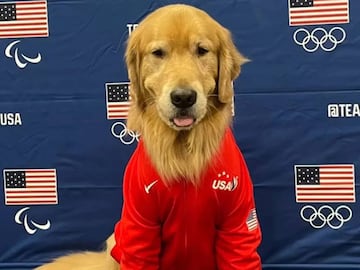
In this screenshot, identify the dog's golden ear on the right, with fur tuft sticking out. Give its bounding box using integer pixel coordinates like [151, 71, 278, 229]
[217, 27, 249, 103]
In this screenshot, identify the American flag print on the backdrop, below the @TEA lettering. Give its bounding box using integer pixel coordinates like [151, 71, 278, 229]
[295, 164, 355, 203]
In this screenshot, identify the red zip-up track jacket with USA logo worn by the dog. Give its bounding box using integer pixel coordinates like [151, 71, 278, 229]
[111, 129, 261, 270]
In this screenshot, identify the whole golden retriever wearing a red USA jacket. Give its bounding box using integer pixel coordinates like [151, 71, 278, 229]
[37, 4, 261, 270]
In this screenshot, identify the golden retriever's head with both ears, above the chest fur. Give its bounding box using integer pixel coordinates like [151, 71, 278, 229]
[126, 5, 247, 132]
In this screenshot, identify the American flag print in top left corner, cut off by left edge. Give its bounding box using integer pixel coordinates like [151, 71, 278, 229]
[0, 1, 49, 38]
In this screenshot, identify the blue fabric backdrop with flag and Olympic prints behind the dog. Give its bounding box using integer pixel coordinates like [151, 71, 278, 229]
[0, 0, 360, 270]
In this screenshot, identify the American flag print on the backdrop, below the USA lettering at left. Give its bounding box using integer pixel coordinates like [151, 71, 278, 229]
[3, 169, 58, 205]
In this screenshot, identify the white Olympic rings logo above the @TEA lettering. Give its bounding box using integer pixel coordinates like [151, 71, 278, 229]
[293, 26, 346, 53]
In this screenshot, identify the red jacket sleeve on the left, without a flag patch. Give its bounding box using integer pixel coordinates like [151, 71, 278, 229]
[111, 151, 161, 270]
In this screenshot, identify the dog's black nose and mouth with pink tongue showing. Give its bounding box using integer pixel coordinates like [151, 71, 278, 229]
[170, 89, 197, 128]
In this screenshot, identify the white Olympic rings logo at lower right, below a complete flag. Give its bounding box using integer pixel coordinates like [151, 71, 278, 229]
[300, 205, 352, 230]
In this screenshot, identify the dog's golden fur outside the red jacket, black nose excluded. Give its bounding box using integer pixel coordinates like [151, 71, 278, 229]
[38, 4, 247, 270]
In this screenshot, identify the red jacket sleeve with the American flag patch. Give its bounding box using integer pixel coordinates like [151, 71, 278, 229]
[215, 155, 261, 270]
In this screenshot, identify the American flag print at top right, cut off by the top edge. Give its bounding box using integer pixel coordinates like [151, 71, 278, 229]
[289, 0, 350, 26]
